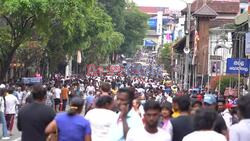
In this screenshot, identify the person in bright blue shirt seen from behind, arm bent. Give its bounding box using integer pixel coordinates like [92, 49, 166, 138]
[45, 97, 91, 141]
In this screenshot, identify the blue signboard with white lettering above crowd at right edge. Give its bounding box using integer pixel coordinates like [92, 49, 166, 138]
[227, 58, 250, 74]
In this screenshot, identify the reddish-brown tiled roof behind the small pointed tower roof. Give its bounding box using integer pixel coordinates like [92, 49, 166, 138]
[181, 0, 240, 14]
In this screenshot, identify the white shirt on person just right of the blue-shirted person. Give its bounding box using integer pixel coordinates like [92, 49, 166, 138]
[85, 108, 117, 141]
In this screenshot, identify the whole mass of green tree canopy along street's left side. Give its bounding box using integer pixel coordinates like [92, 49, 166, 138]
[0, 0, 147, 80]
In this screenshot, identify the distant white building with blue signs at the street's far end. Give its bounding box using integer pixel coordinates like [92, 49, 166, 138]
[139, 6, 180, 50]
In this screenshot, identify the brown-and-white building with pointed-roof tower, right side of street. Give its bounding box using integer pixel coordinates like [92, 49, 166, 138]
[174, 0, 240, 87]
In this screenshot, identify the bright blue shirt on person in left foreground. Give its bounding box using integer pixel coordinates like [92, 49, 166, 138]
[55, 112, 91, 141]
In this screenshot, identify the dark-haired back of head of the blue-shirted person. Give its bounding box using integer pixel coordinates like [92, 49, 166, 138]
[68, 96, 84, 116]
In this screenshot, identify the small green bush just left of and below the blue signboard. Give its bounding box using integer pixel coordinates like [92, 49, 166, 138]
[216, 76, 238, 94]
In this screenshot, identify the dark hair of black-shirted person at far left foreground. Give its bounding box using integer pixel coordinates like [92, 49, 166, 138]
[31, 85, 47, 100]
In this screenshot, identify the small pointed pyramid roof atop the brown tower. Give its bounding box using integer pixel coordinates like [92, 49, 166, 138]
[193, 4, 218, 18]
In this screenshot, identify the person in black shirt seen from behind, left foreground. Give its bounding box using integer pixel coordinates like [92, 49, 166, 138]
[17, 85, 55, 141]
